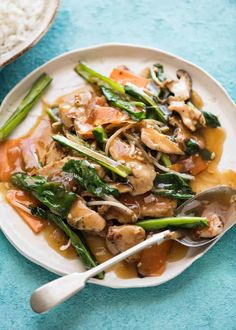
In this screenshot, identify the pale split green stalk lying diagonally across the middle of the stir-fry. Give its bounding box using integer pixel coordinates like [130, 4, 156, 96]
[53, 135, 131, 178]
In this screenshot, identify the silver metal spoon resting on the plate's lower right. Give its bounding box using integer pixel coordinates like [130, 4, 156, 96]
[30, 186, 236, 313]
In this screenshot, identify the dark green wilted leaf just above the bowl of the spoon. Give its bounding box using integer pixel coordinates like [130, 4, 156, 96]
[152, 173, 194, 199]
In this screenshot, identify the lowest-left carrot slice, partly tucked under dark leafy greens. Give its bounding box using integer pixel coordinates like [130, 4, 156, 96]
[6, 190, 47, 234]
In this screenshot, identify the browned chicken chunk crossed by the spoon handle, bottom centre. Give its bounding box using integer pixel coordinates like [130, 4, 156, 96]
[106, 225, 146, 263]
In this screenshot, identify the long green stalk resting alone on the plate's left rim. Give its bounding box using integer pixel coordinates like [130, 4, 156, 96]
[0, 73, 52, 141]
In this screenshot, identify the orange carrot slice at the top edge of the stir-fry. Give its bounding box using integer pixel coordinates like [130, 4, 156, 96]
[110, 68, 148, 88]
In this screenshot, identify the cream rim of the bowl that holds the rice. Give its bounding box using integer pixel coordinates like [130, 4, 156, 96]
[0, 0, 60, 70]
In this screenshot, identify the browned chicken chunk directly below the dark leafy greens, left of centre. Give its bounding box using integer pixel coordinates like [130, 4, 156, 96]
[67, 198, 106, 232]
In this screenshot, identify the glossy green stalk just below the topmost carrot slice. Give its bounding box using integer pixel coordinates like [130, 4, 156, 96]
[101, 87, 145, 121]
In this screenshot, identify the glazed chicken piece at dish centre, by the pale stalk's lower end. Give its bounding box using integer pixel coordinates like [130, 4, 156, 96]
[109, 138, 156, 195]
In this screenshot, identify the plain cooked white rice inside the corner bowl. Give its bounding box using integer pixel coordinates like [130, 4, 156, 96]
[0, 0, 46, 55]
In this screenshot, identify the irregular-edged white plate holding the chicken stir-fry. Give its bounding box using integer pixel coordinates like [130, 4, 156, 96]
[0, 44, 236, 288]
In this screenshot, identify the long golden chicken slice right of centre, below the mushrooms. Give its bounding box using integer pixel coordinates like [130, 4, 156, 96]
[141, 124, 184, 155]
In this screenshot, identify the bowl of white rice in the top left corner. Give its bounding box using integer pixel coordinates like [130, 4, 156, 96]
[0, 0, 60, 68]
